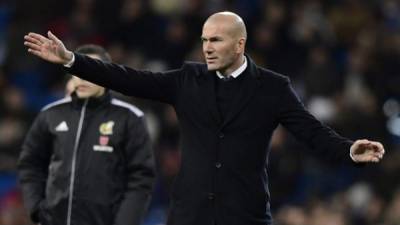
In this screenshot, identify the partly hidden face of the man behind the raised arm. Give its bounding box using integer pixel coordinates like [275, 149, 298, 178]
[70, 54, 105, 98]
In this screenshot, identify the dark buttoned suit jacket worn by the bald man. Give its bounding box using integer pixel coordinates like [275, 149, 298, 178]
[68, 54, 351, 225]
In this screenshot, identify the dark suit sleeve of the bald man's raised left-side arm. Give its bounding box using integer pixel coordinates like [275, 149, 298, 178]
[65, 53, 183, 104]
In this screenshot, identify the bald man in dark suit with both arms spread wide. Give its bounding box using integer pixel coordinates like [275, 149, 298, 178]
[25, 12, 384, 225]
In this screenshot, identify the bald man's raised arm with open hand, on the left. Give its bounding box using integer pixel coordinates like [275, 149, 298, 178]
[24, 31, 184, 104]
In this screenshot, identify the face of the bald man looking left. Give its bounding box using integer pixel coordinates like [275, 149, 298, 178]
[201, 22, 239, 74]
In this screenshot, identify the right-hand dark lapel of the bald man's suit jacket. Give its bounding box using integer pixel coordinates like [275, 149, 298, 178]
[222, 57, 261, 127]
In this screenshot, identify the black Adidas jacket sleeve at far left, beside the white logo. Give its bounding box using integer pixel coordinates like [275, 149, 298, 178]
[18, 112, 52, 223]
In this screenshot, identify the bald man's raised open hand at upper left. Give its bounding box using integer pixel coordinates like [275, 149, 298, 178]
[24, 31, 73, 64]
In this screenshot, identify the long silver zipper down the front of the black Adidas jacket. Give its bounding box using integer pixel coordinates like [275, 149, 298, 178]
[67, 99, 89, 225]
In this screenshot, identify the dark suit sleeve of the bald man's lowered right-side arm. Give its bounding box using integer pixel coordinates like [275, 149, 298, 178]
[278, 78, 355, 164]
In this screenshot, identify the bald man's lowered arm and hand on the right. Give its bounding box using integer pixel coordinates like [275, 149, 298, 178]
[279, 80, 385, 163]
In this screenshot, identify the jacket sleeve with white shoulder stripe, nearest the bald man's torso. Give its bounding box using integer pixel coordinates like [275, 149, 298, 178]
[115, 114, 155, 225]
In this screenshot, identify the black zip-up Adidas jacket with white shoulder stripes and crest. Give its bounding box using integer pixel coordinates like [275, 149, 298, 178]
[18, 92, 155, 225]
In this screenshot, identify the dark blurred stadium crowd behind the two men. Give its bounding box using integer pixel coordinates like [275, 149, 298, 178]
[0, 0, 400, 225]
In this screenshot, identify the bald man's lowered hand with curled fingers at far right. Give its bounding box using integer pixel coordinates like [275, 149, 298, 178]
[350, 139, 385, 162]
